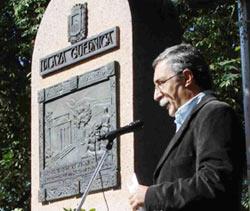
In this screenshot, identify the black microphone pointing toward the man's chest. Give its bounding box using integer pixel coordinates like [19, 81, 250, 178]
[99, 120, 144, 140]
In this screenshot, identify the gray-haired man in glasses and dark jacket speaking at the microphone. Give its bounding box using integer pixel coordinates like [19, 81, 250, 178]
[130, 44, 245, 211]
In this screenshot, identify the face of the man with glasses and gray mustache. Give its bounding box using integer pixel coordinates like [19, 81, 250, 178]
[154, 62, 184, 117]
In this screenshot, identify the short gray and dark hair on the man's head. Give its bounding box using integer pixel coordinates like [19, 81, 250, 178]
[153, 44, 212, 90]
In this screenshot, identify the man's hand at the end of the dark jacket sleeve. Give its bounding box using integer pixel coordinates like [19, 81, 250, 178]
[129, 185, 148, 211]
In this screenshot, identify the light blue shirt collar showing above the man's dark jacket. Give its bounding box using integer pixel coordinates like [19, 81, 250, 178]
[174, 92, 206, 132]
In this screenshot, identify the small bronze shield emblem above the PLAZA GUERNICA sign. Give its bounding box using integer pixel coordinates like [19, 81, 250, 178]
[68, 3, 87, 44]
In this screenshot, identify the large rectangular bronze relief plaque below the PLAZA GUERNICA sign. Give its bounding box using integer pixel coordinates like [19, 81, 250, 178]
[38, 62, 119, 202]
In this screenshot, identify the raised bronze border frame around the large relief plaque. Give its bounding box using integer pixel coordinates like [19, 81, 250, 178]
[38, 61, 121, 203]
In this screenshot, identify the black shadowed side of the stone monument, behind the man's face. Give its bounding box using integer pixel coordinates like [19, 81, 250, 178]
[129, 0, 185, 185]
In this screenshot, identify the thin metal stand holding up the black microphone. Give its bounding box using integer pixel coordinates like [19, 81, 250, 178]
[76, 136, 115, 211]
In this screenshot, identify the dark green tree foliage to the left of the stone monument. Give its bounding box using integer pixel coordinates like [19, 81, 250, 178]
[0, 0, 49, 210]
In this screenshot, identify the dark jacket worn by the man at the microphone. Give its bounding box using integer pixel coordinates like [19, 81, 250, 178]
[145, 95, 245, 211]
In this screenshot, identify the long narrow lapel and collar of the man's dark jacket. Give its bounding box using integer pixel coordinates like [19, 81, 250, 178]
[154, 94, 216, 181]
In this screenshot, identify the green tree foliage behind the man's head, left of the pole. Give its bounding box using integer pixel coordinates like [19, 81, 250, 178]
[178, 0, 242, 114]
